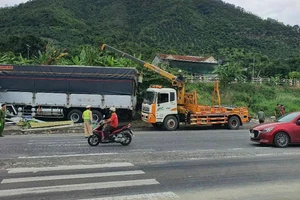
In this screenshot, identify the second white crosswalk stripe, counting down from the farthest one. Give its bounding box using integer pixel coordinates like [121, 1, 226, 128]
[1, 170, 145, 184]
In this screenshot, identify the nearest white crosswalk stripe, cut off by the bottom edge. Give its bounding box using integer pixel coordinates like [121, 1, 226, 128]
[81, 192, 179, 200]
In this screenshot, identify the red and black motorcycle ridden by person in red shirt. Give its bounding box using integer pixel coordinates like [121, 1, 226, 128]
[88, 120, 133, 146]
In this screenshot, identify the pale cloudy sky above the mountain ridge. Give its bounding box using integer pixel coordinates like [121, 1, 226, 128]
[0, 0, 300, 26]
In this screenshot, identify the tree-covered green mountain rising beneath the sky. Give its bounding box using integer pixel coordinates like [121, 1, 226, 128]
[0, 0, 300, 59]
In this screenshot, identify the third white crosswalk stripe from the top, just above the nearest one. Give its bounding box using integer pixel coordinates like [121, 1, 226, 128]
[0, 179, 159, 197]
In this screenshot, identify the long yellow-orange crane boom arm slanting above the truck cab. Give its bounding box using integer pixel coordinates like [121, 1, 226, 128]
[101, 44, 184, 88]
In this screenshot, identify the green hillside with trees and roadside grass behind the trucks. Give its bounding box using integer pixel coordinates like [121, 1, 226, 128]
[0, 0, 300, 115]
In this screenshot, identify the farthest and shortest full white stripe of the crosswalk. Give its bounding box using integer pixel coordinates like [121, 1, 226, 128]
[8, 162, 134, 174]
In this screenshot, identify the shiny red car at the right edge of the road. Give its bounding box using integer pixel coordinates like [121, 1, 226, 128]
[249, 112, 300, 147]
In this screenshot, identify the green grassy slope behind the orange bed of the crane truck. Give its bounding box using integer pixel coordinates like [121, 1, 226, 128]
[187, 83, 300, 117]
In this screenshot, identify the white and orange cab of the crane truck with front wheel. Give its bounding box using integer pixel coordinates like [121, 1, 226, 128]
[142, 86, 178, 130]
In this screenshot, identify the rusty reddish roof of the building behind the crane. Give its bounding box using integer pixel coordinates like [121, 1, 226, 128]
[156, 54, 217, 63]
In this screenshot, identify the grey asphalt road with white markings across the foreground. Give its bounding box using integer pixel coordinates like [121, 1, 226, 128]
[0, 130, 300, 200]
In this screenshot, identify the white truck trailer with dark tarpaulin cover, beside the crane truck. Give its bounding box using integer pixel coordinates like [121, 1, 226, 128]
[0, 65, 137, 123]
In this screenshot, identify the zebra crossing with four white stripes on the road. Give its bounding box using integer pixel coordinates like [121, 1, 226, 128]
[0, 162, 179, 200]
